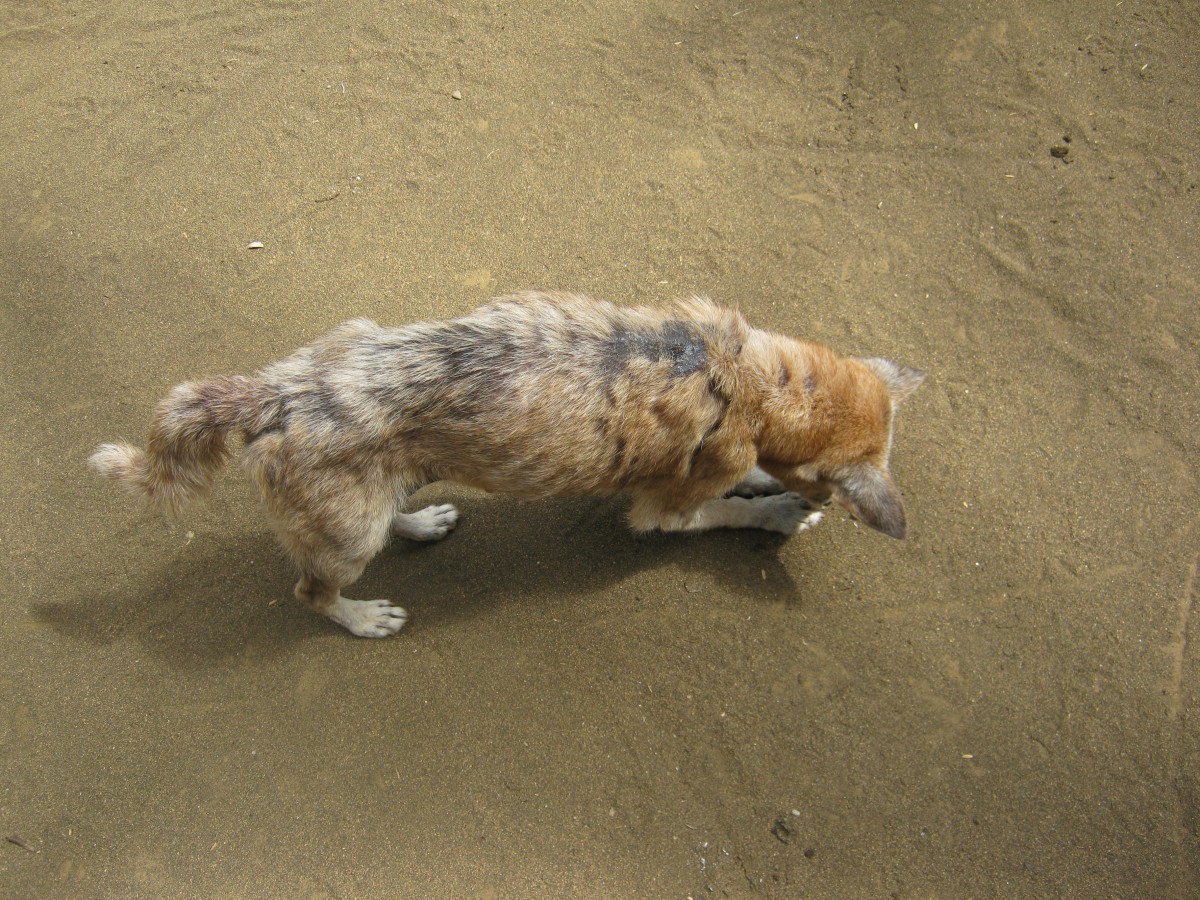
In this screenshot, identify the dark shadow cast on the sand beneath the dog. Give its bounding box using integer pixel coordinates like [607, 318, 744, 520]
[32, 487, 816, 667]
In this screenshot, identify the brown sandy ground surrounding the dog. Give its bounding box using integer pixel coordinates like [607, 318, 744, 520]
[0, 0, 1200, 898]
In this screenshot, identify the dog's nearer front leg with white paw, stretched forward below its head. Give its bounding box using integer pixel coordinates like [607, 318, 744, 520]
[629, 493, 822, 534]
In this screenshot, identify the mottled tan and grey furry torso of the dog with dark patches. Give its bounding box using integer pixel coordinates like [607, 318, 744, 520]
[251, 294, 745, 497]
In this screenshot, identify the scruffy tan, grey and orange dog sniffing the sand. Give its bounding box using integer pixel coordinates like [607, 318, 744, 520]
[90, 292, 924, 637]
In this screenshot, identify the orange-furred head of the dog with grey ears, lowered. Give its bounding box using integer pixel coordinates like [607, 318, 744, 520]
[758, 346, 925, 538]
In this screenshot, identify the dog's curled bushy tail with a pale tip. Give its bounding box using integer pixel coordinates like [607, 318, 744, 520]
[88, 376, 272, 516]
